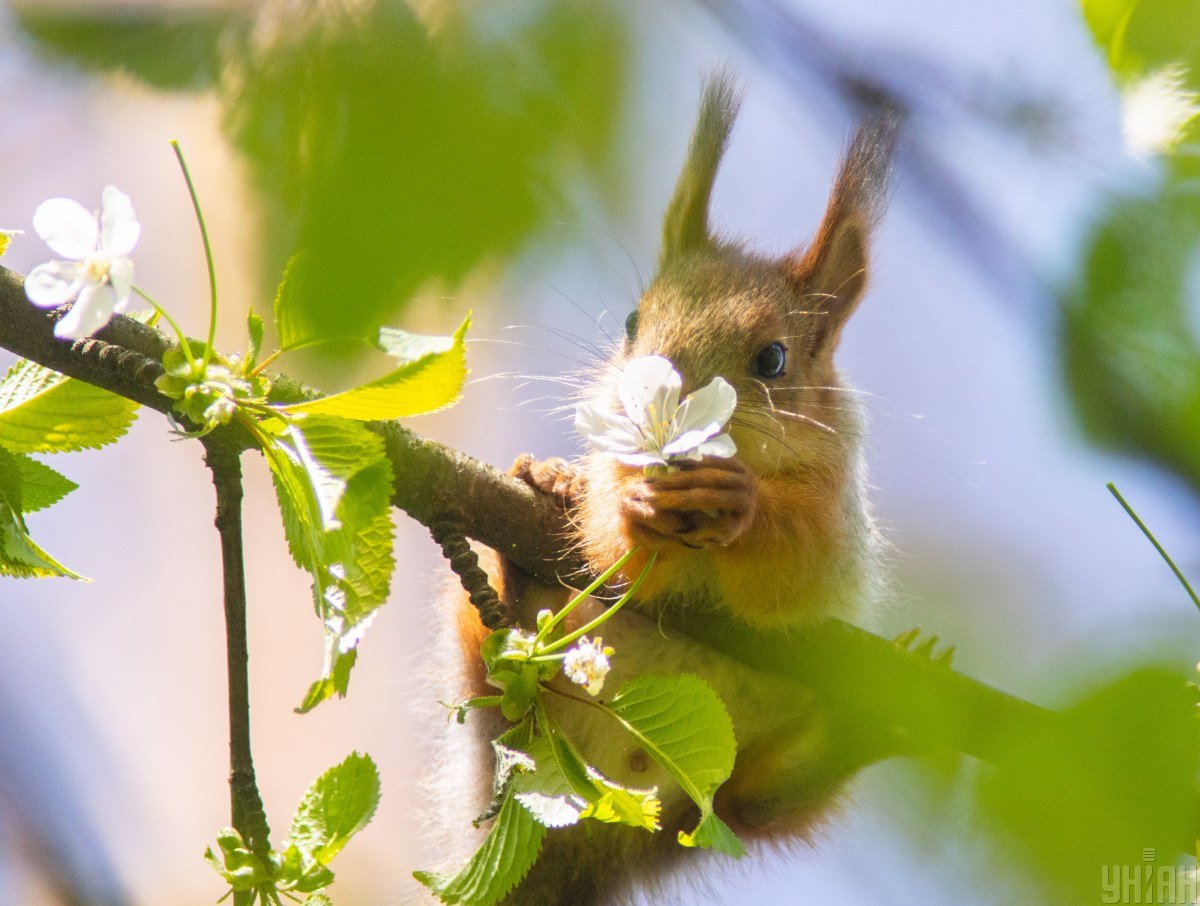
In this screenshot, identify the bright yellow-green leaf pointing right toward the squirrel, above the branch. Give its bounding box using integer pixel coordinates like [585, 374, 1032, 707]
[281, 316, 470, 421]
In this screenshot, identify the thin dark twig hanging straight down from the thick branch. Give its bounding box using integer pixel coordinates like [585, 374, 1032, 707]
[204, 439, 271, 892]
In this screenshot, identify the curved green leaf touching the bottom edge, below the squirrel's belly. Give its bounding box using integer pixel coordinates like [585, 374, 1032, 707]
[413, 794, 546, 906]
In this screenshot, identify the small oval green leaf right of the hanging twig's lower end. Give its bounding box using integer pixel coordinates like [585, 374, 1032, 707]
[290, 752, 379, 865]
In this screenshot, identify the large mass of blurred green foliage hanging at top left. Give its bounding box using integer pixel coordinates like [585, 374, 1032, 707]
[19, 0, 628, 348]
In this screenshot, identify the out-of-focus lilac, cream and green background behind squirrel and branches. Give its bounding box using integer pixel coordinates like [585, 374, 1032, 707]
[0, 0, 1200, 906]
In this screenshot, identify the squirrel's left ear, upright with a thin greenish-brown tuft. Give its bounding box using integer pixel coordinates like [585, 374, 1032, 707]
[659, 72, 742, 268]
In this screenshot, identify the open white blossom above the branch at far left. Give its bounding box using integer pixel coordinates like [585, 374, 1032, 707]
[25, 186, 142, 340]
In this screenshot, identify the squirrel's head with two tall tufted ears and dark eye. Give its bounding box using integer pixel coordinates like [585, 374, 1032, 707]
[622, 76, 896, 473]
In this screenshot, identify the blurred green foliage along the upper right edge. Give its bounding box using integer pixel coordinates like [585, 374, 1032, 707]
[1075, 0, 1200, 490]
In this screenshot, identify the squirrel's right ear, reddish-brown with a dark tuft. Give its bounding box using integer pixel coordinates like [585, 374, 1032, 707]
[784, 109, 900, 350]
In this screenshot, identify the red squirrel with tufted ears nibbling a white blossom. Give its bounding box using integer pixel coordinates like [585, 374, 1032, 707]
[436, 74, 898, 906]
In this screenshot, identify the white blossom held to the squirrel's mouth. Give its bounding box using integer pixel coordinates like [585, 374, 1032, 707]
[575, 355, 738, 466]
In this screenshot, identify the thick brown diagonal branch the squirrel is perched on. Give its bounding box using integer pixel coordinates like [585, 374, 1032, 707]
[0, 268, 1056, 762]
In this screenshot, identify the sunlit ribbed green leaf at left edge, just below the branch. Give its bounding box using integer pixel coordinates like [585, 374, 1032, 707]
[0, 360, 138, 452]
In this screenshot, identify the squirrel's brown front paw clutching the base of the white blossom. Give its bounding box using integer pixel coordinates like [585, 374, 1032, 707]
[620, 458, 757, 550]
